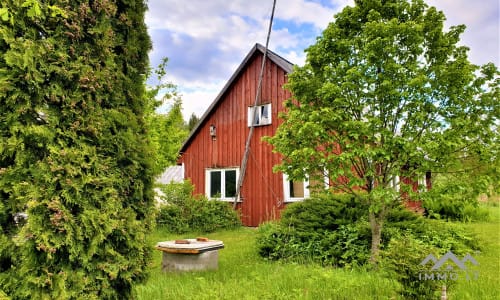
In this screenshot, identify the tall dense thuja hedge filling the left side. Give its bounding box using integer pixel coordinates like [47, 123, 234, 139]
[0, 0, 153, 299]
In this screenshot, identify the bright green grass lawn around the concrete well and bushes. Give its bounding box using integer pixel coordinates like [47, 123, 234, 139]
[136, 207, 500, 300]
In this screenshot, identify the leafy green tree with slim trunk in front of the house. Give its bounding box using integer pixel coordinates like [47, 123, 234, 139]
[269, 0, 499, 263]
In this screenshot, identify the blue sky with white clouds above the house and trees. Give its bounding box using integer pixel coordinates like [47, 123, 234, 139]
[146, 0, 500, 121]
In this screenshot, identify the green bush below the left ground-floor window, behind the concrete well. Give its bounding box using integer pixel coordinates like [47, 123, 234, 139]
[157, 181, 241, 233]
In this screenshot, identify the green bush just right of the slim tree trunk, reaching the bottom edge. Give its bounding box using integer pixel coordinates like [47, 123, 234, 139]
[380, 209, 480, 299]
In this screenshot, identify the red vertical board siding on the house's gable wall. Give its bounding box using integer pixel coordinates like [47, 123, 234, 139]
[181, 53, 290, 226]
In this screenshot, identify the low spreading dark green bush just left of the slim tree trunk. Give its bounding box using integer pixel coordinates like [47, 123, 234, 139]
[257, 194, 371, 266]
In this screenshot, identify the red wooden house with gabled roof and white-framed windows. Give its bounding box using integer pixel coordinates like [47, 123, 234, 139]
[180, 44, 428, 226]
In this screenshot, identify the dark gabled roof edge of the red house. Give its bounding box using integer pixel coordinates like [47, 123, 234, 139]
[180, 43, 293, 153]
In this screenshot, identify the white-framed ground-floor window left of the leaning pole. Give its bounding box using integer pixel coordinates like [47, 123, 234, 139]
[205, 168, 240, 201]
